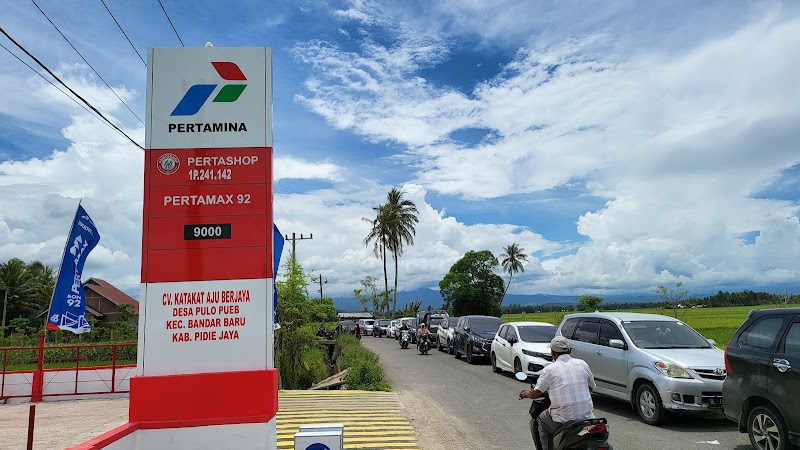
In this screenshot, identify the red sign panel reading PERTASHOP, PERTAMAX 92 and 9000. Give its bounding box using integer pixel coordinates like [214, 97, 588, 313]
[142, 147, 272, 283]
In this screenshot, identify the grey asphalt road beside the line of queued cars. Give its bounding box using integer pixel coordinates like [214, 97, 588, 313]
[361, 336, 752, 450]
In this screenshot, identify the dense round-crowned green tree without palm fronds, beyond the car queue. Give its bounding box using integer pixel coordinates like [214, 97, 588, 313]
[439, 250, 505, 317]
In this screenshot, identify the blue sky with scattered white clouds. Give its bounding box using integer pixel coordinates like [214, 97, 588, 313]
[0, 0, 800, 298]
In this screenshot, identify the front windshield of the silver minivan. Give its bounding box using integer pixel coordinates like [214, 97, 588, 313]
[622, 320, 711, 348]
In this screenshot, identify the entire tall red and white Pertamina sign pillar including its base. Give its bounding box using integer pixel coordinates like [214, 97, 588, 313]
[136, 48, 278, 449]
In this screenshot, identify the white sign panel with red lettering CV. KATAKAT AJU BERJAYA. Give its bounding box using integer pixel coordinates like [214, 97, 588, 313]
[139, 278, 273, 376]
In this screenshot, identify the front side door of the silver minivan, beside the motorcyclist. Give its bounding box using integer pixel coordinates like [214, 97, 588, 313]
[590, 319, 628, 394]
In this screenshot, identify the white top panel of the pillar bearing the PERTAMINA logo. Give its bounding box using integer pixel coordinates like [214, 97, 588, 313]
[146, 48, 272, 149]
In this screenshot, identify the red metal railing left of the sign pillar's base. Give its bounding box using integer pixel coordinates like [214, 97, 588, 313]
[0, 333, 137, 402]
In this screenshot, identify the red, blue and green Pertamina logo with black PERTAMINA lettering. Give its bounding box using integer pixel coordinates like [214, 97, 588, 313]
[168, 61, 252, 133]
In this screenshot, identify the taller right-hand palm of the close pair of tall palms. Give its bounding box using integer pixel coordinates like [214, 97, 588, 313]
[384, 188, 419, 318]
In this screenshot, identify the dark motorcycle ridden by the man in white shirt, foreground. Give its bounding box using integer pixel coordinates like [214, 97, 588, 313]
[514, 372, 614, 450]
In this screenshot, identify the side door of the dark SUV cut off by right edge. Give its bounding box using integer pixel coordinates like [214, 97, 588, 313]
[770, 315, 800, 433]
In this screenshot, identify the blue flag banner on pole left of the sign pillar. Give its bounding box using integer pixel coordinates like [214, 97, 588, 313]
[47, 205, 100, 334]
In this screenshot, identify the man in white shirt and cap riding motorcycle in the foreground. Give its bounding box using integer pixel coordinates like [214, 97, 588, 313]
[519, 336, 595, 450]
